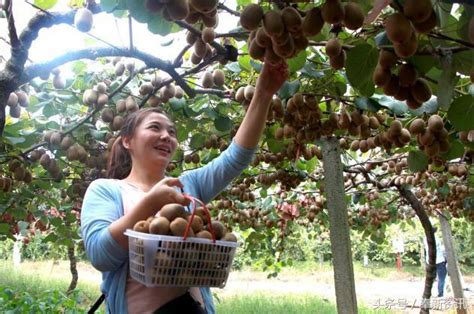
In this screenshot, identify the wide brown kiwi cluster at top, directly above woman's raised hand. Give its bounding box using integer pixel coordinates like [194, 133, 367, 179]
[240, 0, 364, 69]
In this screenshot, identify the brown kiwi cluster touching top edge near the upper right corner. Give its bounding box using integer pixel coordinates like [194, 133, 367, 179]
[385, 0, 437, 58]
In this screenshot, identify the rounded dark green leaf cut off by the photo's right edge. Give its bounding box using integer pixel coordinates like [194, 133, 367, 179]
[448, 95, 474, 131]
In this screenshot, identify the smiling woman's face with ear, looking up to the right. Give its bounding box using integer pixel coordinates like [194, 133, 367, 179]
[123, 112, 178, 167]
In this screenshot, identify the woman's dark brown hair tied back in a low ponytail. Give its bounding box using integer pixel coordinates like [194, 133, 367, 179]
[107, 107, 172, 180]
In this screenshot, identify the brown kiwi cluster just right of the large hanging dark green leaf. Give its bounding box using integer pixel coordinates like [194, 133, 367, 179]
[372, 49, 432, 110]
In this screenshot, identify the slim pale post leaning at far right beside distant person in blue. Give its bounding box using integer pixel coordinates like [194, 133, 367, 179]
[439, 215, 467, 314]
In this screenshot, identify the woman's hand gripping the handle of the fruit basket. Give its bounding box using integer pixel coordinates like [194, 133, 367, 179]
[145, 178, 190, 216]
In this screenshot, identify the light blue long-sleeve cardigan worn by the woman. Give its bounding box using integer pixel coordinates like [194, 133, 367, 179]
[81, 142, 256, 314]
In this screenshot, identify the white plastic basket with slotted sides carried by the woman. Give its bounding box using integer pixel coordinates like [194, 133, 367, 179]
[125, 229, 239, 288]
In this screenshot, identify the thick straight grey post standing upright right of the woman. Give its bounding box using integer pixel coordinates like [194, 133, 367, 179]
[323, 137, 357, 314]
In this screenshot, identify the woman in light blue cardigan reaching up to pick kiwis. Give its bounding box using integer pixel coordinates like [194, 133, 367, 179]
[81, 64, 288, 313]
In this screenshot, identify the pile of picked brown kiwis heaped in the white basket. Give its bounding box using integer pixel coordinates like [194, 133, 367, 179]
[133, 203, 237, 242]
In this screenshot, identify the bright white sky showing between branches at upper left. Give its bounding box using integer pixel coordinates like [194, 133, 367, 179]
[0, 0, 238, 68]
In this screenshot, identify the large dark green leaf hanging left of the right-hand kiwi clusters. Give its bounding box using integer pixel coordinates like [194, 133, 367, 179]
[346, 44, 379, 96]
